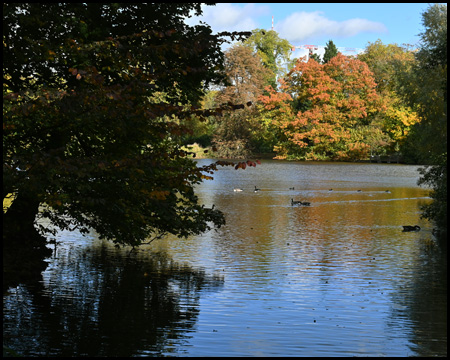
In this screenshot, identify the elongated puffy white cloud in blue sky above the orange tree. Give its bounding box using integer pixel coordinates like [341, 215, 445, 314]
[275, 11, 387, 43]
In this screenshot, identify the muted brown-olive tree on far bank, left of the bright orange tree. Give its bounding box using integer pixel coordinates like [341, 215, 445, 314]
[214, 44, 270, 158]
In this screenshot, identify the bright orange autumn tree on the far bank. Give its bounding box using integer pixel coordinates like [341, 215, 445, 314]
[274, 54, 385, 160]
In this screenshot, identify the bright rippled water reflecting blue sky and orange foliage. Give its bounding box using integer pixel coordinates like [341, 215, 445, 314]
[149, 162, 446, 356]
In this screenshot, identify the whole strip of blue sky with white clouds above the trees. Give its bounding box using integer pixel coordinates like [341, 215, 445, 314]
[187, 3, 428, 57]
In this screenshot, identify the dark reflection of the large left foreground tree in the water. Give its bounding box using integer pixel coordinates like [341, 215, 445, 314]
[3, 246, 224, 356]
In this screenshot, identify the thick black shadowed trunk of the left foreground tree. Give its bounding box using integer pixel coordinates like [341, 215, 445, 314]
[3, 193, 52, 290]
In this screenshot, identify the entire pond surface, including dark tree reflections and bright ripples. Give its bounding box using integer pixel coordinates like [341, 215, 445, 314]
[3, 159, 447, 356]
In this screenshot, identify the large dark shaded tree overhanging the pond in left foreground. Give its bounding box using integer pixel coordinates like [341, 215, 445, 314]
[3, 3, 253, 284]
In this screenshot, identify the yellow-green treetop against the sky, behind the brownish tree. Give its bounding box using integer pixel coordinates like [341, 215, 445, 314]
[244, 29, 293, 89]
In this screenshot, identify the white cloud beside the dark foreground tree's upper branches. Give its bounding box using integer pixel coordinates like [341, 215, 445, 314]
[186, 3, 269, 32]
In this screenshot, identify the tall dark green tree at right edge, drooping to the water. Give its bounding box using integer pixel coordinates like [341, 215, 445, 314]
[403, 4, 447, 233]
